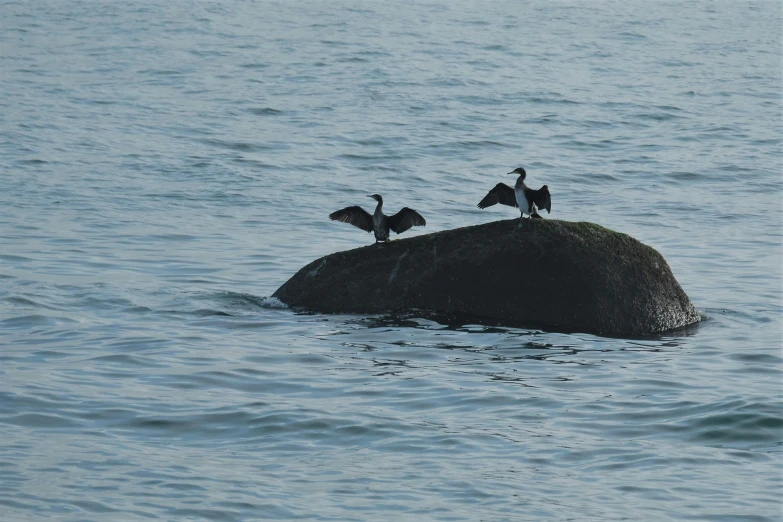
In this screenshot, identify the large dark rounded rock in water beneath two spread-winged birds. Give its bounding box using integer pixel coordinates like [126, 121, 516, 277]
[274, 219, 699, 337]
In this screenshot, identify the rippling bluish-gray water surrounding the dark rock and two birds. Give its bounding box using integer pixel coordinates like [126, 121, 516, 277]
[0, 0, 783, 521]
